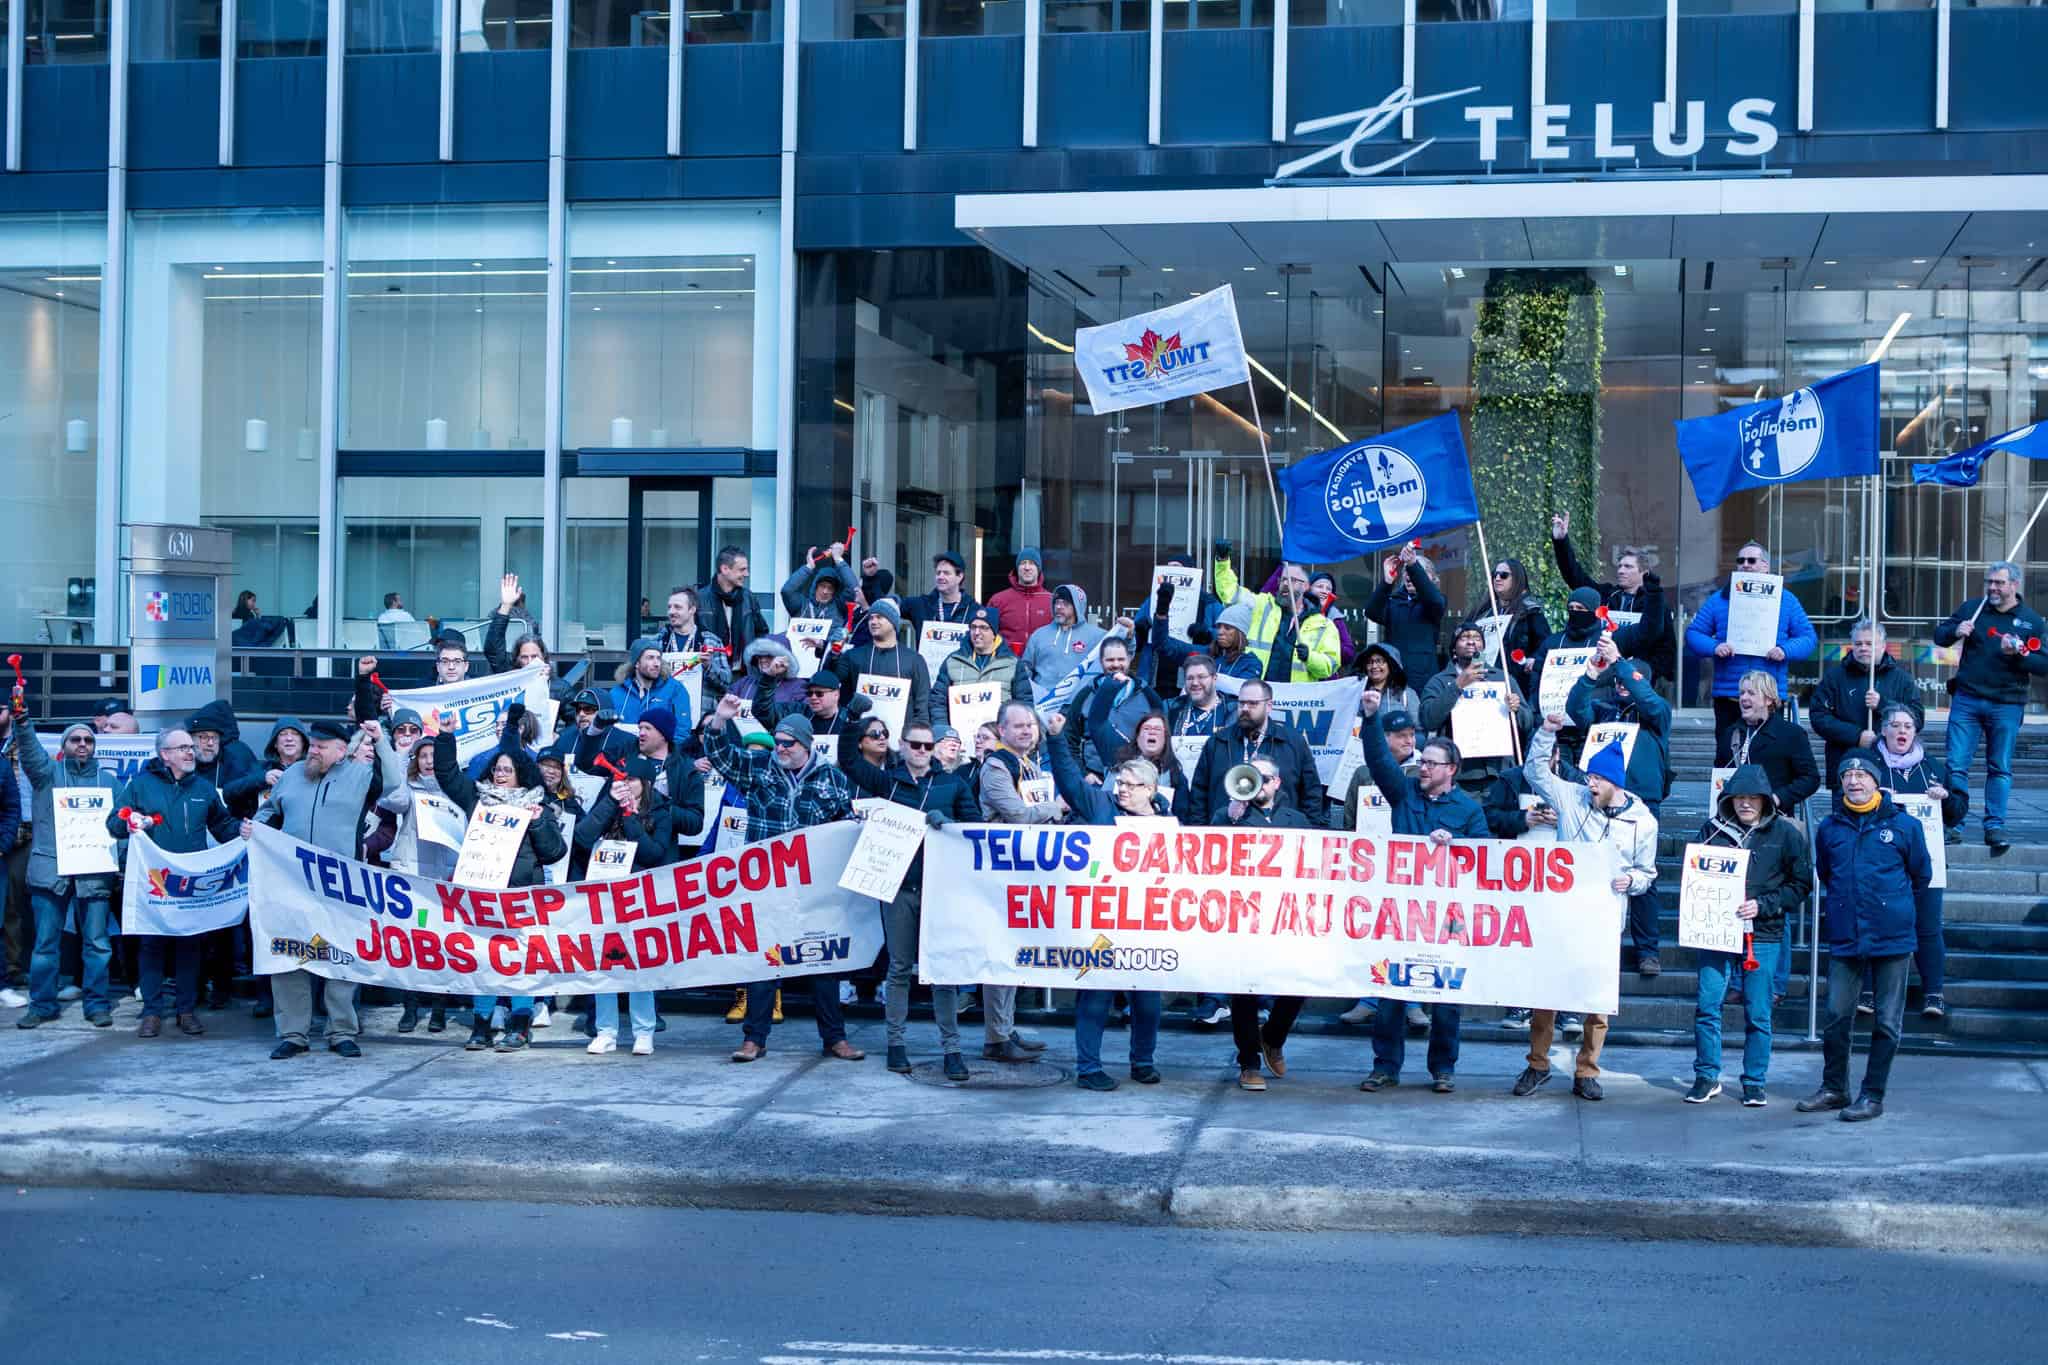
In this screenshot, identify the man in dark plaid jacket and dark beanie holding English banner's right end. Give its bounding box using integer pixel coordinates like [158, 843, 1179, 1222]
[705, 692, 866, 1062]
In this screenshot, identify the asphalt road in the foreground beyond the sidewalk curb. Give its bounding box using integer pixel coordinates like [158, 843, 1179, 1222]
[0, 1186, 2048, 1365]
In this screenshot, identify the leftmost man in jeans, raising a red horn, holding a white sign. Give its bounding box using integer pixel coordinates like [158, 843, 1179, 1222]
[0, 712, 119, 1029]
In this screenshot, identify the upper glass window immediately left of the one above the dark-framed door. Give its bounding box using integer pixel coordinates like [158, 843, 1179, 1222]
[342, 207, 547, 450]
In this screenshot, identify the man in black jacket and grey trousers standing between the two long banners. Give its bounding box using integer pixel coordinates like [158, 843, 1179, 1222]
[840, 716, 981, 1081]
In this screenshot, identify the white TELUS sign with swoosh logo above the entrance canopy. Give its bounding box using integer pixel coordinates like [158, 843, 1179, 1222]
[1274, 86, 1778, 180]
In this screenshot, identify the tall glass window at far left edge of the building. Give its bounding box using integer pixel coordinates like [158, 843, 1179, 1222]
[0, 215, 113, 643]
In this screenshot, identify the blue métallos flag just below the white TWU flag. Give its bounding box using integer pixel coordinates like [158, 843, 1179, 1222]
[1280, 411, 1479, 565]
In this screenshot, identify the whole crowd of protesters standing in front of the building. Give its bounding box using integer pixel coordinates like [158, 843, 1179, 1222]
[0, 516, 2048, 1119]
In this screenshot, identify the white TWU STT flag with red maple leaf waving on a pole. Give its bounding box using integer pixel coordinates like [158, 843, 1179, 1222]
[1073, 284, 1251, 413]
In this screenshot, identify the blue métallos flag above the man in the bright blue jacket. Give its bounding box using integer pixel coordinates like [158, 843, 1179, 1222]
[1673, 362, 1878, 512]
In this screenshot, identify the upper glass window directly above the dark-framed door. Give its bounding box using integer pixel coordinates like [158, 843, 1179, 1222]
[563, 205, 776, 450]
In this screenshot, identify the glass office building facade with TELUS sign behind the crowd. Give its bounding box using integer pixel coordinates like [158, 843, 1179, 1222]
[0, 0, 2048, 700]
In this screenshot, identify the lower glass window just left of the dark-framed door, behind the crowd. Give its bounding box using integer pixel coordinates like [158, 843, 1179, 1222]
[336, 477, 541, 649]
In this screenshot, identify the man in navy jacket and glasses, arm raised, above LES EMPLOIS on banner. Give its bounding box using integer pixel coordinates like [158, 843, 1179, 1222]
[1358, 690, 1489, 1095]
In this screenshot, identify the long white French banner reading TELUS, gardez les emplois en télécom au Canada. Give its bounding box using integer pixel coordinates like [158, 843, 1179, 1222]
[918, 825, 1626, 1015]
